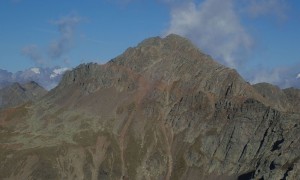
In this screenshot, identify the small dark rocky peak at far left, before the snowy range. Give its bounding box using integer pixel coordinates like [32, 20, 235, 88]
[0, 81, 47, 109]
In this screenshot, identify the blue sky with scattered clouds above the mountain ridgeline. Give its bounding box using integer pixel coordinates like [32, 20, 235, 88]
[0, 0, 300, 87]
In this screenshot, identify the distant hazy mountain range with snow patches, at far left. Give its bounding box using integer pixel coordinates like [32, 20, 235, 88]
[0, 67, 68, 90]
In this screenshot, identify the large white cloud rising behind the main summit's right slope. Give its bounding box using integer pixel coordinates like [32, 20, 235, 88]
[166, 0, 253, 67]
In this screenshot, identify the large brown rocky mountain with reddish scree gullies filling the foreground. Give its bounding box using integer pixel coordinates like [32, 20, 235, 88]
[0, 35, 300, 179]
